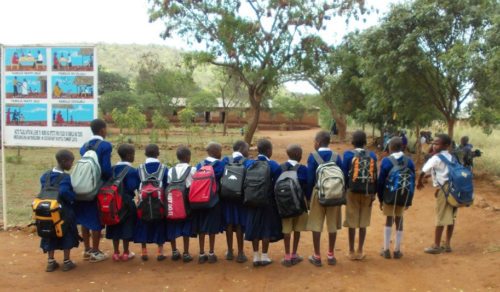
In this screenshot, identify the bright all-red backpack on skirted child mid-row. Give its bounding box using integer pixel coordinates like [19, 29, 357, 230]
[189, 161, 219, 209]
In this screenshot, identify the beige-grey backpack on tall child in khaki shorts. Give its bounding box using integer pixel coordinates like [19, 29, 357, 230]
[312, 151, 346, 207]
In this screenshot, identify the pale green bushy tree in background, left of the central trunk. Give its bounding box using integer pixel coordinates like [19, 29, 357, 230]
[136, 53, 198, 114]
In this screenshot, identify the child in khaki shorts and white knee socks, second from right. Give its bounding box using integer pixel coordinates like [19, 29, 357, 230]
[377, 137, 415, 259]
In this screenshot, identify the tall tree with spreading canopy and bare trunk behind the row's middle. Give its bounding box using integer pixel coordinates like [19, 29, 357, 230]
[150, 0, 364, 143]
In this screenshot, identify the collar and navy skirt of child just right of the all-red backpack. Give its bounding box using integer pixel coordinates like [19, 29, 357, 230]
[221, 153, 247, 231]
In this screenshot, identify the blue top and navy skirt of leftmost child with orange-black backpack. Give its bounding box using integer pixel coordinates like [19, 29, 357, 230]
[40, 169, 79, 252]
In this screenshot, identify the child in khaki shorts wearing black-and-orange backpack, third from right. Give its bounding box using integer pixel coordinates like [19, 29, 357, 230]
[342, 130, 377, 260]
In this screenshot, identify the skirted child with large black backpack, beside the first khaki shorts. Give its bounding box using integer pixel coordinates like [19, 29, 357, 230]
[245, 139, 283, 267]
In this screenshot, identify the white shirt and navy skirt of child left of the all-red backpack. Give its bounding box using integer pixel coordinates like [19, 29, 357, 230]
[166, 163, 196, 241]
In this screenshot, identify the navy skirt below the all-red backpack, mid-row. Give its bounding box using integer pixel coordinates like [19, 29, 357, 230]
[191, 202, 223, 234]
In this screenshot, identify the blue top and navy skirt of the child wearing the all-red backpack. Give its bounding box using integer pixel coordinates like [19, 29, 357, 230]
[192, 159, 224, 234]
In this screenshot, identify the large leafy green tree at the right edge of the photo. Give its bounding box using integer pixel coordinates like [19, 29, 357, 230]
[377, 0, 498, 136]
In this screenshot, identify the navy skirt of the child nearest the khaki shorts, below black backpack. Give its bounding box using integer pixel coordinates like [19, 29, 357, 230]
[245, 205, 283, 242]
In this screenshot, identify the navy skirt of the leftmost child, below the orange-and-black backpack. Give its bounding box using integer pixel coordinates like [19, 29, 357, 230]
[40, 210, 79, 253]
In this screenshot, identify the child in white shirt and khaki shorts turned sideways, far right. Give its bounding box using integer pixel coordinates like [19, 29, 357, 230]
[417, 134, 457, 254]
